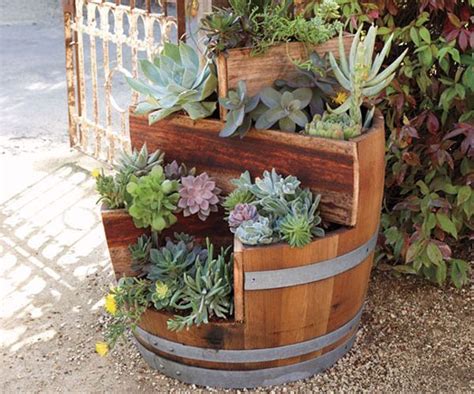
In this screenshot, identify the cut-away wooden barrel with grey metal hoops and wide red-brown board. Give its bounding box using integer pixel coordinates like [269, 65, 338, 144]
[125, 109, 385, 388]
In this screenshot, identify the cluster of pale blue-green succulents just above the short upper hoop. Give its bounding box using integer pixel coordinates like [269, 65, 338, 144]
[224, 169, 324, 247]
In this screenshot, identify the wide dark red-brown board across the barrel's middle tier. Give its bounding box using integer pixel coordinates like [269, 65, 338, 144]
[130, 114, 359, 225]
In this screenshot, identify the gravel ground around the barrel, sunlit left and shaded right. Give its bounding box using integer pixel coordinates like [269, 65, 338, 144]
[0, 149, 474, 393]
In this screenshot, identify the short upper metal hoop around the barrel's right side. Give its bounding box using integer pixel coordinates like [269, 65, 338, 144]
[244, 231, 378, 290]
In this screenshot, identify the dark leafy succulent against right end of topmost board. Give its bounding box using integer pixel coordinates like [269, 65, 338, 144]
[275, 52, 337, 116]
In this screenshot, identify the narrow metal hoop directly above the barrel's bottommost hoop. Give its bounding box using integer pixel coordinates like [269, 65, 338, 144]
[131, 308, 362, 363]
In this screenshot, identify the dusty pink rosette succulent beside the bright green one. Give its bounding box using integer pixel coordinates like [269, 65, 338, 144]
[178, 172, 221, 221]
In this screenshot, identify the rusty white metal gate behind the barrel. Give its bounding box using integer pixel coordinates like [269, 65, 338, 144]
[63, 0, 191, 163]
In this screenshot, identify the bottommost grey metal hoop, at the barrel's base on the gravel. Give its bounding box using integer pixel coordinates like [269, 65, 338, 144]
[137, 333, 356, 388]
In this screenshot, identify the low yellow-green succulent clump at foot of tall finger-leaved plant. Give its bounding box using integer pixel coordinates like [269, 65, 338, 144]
[304, 112, 361, 140]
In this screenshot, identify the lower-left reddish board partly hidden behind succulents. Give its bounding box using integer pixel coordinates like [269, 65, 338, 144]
[101, 208, 232, 279]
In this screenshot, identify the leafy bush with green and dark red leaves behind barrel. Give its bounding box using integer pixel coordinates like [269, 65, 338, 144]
[338, 0, 474, 287]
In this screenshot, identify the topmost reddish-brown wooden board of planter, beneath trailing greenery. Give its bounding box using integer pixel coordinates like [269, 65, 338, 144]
[217, 34, 352, 119]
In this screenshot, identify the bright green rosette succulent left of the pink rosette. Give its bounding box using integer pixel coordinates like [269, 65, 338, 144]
[127, 166, 179, 231]
